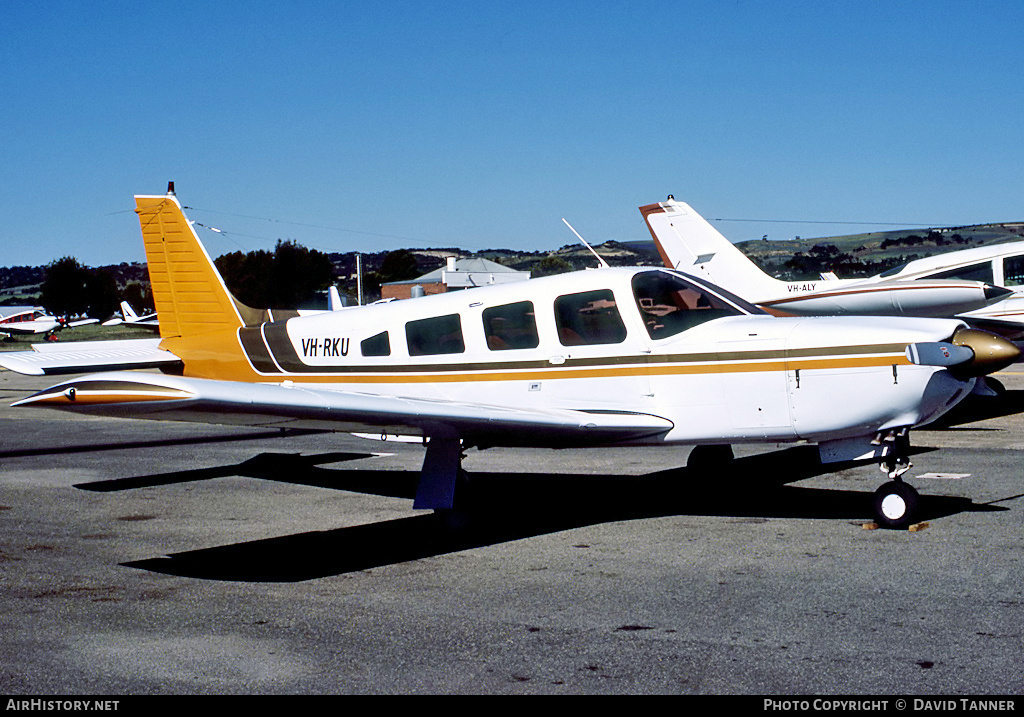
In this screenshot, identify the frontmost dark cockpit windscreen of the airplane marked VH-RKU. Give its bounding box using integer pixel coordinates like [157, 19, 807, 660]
[633, 271, 740, 339]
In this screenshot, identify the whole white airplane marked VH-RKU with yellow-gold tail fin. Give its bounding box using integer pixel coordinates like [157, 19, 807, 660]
[4, 189, 1019, 526]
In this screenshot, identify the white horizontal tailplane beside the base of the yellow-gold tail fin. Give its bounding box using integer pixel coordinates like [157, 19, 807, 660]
[0, 338, 181, 376]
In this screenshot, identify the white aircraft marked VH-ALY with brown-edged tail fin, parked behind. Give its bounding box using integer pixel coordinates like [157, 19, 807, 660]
[640, 197, 1013, 317]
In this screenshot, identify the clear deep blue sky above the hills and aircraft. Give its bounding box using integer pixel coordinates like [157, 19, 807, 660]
[0, 0, 1024, 266]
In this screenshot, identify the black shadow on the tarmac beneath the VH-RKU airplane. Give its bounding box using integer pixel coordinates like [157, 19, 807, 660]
[70, 446, 1007, 582]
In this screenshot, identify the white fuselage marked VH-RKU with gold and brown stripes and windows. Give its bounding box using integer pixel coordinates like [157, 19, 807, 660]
[174, 268, 973, 444]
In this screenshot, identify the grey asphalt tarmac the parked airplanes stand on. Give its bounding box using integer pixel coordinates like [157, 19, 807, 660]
[0, 365, 1024, 695]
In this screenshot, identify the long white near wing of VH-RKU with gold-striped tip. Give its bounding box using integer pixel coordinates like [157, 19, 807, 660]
[13, 372, 673, 448]
